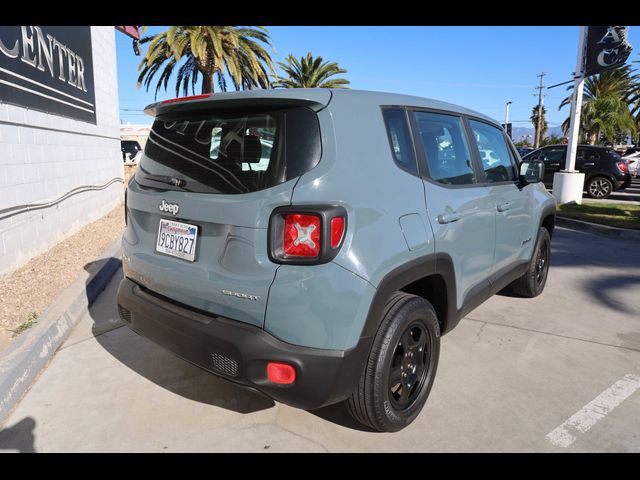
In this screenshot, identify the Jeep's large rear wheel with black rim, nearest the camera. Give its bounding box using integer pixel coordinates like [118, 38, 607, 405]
[345, 292, 440, 432]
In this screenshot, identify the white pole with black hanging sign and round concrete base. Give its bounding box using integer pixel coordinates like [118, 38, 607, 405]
[553, 26, 631, 204]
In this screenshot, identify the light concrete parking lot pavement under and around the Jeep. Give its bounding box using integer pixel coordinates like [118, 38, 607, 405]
[0, 228, 640, 452]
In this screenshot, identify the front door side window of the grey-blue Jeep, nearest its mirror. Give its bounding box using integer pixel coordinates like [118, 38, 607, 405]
[469, 120, 516, 183]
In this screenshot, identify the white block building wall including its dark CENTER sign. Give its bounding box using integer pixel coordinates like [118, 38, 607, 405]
[0, 26, 124, 277]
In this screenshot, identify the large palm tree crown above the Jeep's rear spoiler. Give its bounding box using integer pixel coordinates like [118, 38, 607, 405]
[137, 26, 275, 97]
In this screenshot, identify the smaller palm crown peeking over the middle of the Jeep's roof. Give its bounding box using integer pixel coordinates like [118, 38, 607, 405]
[274, 52, 350, 88]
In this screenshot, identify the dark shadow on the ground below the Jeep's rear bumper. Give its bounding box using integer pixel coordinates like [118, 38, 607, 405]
[85, 259, 275, 414]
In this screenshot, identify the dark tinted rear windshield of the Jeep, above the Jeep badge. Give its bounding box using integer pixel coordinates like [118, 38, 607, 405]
[136, 108, 321, 194]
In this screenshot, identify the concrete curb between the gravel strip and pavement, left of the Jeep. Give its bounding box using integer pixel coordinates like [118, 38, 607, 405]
[0, 238, 122, 424]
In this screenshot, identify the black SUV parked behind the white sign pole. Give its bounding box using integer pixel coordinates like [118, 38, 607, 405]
[522, 145, 631, 198]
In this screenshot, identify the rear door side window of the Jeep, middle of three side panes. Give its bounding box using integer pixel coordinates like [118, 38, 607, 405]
[413, 112, 476, 185]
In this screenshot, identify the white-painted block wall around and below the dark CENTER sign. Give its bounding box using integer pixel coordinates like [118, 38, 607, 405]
[0, 26, 124, 277]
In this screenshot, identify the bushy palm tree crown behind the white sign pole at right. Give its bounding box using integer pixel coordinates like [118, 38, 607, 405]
[558, 65, 640, 145]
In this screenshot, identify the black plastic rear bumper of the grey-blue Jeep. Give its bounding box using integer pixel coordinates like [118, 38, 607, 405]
[118, 278, 369, 409]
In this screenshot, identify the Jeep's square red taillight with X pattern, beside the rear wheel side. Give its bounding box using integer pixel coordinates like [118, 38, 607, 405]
[269, 205, 347, 265]
